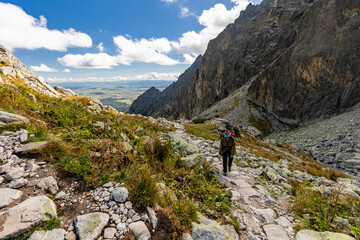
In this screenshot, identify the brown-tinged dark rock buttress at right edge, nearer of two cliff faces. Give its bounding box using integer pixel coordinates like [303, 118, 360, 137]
[248, 0, 360, 122]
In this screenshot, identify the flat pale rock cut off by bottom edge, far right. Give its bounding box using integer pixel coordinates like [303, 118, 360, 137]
[295, 230, 355, 240]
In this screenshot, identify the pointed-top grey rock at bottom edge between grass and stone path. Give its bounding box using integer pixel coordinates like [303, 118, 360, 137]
[191, 214, 231, 240]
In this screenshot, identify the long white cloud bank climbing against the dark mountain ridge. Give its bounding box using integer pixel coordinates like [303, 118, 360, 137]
[58, 0, 249, 68]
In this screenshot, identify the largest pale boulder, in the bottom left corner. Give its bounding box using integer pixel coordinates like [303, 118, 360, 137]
[0, 196, 57, 239]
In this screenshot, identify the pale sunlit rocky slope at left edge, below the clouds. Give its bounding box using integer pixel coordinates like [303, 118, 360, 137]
[0, 45, 61, 97]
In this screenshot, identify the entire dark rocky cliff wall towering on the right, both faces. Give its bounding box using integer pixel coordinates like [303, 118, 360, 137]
[134, 0, 360, 127]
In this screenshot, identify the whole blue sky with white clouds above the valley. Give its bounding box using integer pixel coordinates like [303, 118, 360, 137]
[0, 0, 260, 82]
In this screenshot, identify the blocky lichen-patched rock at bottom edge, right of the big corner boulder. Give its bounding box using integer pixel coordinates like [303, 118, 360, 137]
[74, 212, 109, 240]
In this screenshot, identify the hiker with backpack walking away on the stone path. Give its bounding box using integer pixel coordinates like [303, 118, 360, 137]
[219, 130, 236, 176]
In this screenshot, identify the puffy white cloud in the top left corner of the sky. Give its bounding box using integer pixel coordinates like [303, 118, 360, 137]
[0, 2, 92, 51]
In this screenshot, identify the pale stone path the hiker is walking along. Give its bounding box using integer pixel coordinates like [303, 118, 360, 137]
[168, 123, 360, 240]
